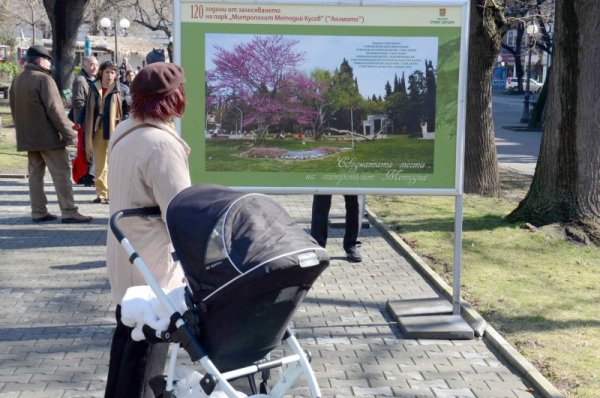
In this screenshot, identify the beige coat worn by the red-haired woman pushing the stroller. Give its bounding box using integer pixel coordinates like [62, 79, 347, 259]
[106, 117, 191, 304]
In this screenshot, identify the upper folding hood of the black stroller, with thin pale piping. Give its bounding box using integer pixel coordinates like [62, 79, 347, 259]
[167, 185, 318, 298]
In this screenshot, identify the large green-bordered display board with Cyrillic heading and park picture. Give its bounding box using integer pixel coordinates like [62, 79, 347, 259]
[174, 0, 468, 195]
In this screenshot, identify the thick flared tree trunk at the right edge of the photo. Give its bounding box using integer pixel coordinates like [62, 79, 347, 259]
[507, 0, 600, 244]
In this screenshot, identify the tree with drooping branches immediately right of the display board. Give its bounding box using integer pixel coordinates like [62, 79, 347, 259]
[464, 0, 554, 195]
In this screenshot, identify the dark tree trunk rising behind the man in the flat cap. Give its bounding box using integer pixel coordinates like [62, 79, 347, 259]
[44, 0, 89, 92]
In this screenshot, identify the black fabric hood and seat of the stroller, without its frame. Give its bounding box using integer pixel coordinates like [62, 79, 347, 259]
[166, 185, 329, 370]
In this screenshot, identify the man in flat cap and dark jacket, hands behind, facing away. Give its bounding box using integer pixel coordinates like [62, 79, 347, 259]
[9, 46, 92, 223]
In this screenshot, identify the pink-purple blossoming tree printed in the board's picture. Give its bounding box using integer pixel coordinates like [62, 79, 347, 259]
[206, 35, 319, 140]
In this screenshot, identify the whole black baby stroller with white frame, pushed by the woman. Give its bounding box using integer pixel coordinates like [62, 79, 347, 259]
[110, 185, 329, 398]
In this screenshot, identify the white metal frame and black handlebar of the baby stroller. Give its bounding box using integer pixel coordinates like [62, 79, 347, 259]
[110, 207, 321, 398]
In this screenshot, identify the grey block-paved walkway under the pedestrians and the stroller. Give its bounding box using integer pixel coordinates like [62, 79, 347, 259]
[0, 179, 537, 398]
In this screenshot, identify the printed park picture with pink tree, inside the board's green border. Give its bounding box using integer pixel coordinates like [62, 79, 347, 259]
[203, 33, 439, 174]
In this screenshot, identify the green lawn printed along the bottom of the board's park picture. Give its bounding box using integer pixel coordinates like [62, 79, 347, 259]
[206, 136, 433, 173]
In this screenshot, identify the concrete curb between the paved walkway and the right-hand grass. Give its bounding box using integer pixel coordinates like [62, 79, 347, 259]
[366, 208, 565, 398]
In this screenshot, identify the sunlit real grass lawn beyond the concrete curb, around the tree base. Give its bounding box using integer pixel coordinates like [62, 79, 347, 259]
[367, 172, 600, 398]
